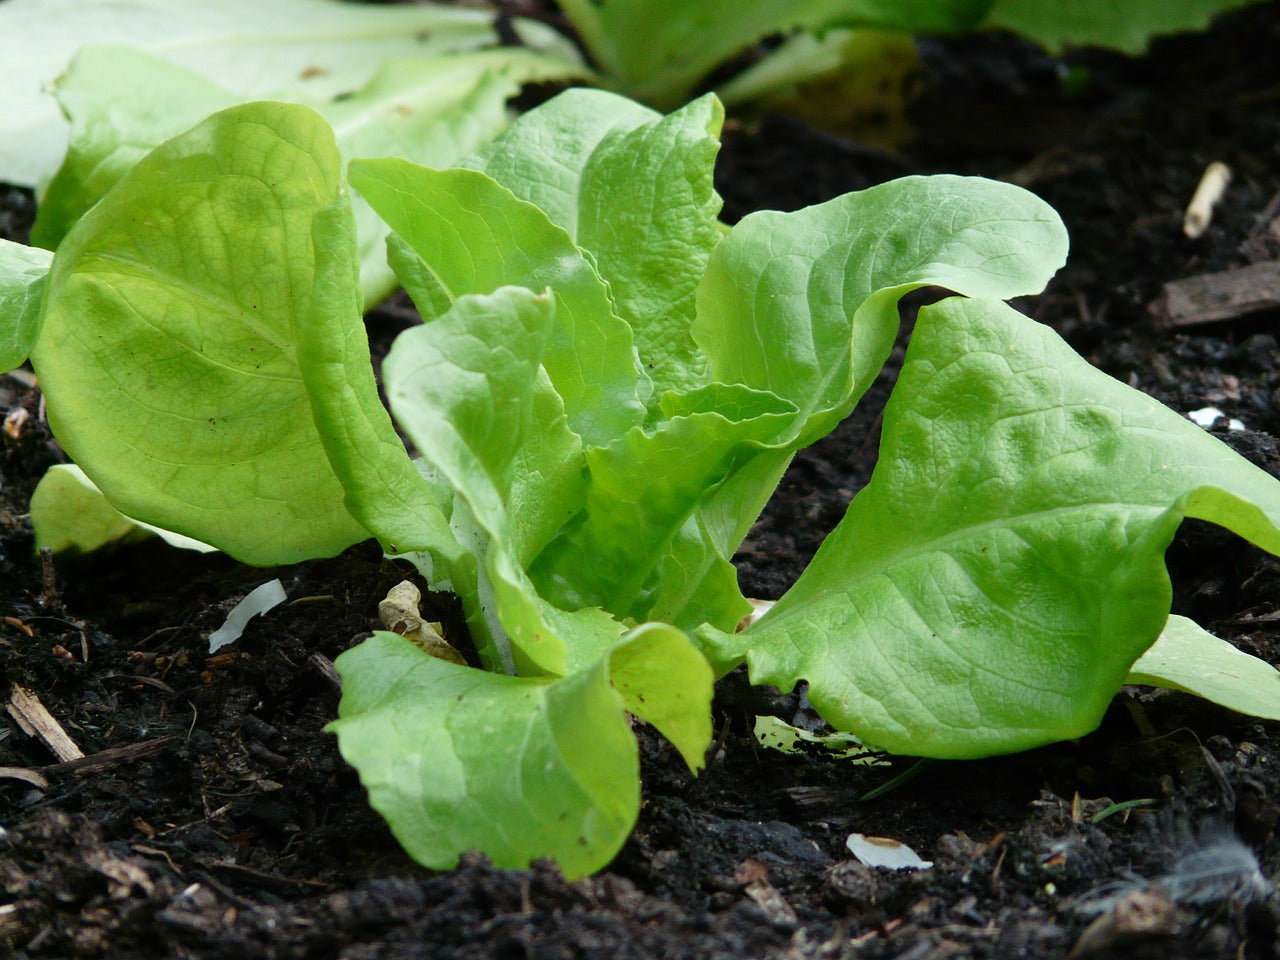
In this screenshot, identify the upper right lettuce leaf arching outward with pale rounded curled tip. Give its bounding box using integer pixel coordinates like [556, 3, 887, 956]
[694, 177, 1068, 447]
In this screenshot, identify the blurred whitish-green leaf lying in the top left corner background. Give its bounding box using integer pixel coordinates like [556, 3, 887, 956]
[0, 0, 577, 192]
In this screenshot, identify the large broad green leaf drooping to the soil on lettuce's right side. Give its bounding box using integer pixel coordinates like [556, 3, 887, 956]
[708, 300, 1280, 756]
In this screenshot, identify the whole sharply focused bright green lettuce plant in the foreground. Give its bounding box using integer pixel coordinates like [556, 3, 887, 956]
[0, 91, 1280, 876]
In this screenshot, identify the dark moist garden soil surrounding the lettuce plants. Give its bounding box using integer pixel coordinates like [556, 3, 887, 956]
[0, 4, 1280, 960]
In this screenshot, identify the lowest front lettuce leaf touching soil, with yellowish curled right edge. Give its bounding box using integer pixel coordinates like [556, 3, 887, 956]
[329, 625, 712, 878]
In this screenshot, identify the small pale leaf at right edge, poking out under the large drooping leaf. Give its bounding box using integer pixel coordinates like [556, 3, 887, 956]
[1125, 617, 1280, 721]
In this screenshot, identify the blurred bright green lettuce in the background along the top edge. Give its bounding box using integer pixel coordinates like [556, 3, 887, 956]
[559, 0, 1257, 109]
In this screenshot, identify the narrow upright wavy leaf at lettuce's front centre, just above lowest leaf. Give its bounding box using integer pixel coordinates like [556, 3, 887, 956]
[383, 287, 622, 675]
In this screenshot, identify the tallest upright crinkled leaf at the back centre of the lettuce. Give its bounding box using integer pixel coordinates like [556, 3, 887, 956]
[466, 91, 724, 401]
